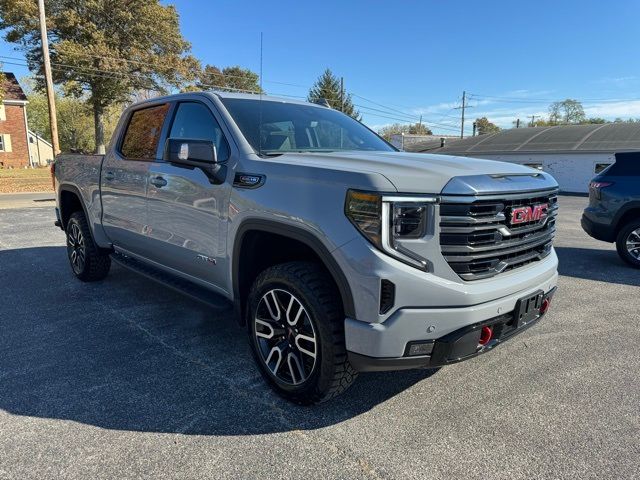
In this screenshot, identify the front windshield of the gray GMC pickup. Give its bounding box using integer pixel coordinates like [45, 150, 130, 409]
[221, 98, 394, 155]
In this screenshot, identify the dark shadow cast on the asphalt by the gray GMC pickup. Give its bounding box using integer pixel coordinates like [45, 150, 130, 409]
[0, 247, 434, 435]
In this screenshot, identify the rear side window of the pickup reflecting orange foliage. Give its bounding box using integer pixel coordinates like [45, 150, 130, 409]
[120, 103, 169, 159]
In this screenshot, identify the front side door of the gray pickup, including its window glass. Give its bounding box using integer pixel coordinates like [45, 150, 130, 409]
[147, 102, 232, 292]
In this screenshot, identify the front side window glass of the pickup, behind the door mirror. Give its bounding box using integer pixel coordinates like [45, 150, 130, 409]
[169, 102, 229, 161]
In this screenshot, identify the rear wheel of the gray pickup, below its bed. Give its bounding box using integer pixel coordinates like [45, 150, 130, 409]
[65, 212, 111, 282]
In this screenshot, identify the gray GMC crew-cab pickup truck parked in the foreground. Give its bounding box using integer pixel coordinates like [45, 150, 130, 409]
[54, 93, 558, 404]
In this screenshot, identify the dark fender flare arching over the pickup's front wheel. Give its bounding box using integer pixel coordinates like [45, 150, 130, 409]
[231, 219, 356, 318]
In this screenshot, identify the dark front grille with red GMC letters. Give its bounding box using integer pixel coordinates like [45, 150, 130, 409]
[440, 191, 558, 280]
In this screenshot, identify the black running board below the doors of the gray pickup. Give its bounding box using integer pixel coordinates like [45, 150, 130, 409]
[111, 252, 233, 312]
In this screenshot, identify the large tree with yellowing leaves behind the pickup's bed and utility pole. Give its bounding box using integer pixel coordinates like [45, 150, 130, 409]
[0, 0, 199, 152]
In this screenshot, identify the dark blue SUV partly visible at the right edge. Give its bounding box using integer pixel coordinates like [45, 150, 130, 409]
[582, 152, 640, 268]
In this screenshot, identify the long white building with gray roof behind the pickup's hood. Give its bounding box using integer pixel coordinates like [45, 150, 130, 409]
[406, 123, 640, 193]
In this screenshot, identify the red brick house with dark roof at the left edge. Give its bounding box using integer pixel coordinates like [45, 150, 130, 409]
[0, 72, 31, 168]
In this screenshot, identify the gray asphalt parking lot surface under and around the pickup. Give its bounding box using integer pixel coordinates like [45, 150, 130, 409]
[0, 196, 640, 479]
